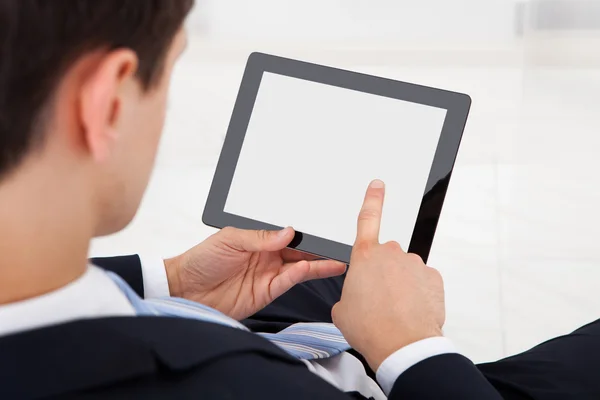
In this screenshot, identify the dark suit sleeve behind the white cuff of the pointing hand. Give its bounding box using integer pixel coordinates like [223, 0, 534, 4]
[389, 354, 502, 400]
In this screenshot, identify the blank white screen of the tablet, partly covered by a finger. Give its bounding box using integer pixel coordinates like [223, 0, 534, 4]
[225, 73, 447, 249]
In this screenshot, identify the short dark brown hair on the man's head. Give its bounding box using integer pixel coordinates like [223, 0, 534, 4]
[0, 0, 194, 178]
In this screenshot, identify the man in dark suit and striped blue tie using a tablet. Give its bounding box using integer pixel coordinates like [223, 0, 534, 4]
[0, 0, 600, 400]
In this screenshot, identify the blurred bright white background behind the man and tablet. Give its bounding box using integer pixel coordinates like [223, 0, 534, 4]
[91, 0, 600, 362]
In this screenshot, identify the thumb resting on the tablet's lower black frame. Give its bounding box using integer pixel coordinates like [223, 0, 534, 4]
[223, 228, 295, 251]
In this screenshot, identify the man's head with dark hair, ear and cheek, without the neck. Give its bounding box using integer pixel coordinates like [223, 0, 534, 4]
[0, 0, 194, 235]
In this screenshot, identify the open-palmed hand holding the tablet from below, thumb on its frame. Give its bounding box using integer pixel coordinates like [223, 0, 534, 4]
[165, 228, 346, 320]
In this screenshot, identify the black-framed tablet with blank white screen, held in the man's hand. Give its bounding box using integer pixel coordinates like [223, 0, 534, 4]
[203, 53, 471, 263]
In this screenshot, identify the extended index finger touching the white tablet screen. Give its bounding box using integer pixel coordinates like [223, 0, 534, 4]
[356, 180, 385, 243]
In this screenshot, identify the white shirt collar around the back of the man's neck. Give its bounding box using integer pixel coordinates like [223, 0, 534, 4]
[0, 266, 135, 336]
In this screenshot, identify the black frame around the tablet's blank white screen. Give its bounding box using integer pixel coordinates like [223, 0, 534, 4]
[202, 53, 471, 263]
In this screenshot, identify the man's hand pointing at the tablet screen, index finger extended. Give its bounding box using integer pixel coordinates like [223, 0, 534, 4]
[332, 181, 445, 371]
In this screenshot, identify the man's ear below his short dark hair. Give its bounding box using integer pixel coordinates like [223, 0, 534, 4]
[79, 49, 138, 162]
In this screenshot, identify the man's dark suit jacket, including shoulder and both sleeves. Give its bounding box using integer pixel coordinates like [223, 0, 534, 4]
[0, 257, 501, 400]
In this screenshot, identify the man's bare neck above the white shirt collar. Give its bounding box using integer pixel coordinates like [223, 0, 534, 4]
[0, 161, 93, 304]
